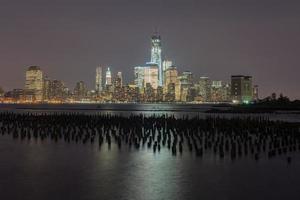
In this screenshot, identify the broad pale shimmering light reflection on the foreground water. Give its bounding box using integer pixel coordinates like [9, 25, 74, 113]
[125, 150, 184, 199]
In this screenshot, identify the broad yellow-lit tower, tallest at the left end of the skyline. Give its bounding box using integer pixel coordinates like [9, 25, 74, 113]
[25, 66, 44, 101]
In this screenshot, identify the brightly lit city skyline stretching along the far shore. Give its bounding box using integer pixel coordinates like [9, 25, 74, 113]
[0, 32, 259, 104]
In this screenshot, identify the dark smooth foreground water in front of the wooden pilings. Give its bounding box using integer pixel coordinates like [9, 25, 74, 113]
[0, 104, 300, 200]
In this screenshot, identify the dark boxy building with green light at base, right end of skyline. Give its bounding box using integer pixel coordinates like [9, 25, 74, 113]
[231, 75, 253, 103]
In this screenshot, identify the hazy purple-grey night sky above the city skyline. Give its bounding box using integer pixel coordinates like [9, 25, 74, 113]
[0, 0, 300, 98]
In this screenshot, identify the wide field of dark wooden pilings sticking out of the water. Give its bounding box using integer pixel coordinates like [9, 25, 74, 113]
[0, 113, 300, 163]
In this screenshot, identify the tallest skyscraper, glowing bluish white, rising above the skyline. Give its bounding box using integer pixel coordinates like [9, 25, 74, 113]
[151, 33, 163, 86]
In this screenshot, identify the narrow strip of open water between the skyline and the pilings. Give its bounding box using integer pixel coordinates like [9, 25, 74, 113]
[0, 104, 300, 122]
